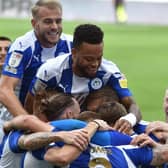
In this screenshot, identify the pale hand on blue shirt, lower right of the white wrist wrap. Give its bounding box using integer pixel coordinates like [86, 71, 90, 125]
[130, 133, 158, 147]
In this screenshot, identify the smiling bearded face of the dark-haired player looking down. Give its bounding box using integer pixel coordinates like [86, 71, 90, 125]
[72, 42, 103, 78]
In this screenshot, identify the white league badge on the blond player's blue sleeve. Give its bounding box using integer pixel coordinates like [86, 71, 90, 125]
[9, 52, 23, 68]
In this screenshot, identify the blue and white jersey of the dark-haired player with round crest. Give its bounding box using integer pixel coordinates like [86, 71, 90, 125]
[30, 54, 132, 103]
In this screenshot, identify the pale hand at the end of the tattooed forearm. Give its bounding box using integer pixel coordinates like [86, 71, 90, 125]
[62, 129, 89, 151]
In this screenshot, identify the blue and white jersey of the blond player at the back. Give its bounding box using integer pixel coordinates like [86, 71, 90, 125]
[2, 30, 73, 104]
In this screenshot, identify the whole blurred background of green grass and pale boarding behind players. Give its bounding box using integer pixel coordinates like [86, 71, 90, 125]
[0, 0, 168, 121]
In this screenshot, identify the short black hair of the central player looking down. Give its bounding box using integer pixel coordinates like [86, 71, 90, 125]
[73, 24, 104, 48]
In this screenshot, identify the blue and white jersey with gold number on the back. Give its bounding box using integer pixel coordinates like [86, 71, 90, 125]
[70, 144, 153, 168]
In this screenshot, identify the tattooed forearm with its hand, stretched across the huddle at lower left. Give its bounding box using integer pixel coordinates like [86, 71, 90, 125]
[18, 129, 88, 150]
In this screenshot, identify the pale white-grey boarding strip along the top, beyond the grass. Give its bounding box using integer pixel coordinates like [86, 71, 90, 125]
[0, 0, 168, 24]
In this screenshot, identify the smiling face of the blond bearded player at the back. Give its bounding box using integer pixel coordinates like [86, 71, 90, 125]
[32, 6, 62, 48]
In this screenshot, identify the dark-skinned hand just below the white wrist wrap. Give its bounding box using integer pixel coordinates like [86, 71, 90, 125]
[114, 119, 132, 135]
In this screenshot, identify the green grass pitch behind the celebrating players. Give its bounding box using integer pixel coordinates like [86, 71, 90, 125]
[0, 19, 168, 121]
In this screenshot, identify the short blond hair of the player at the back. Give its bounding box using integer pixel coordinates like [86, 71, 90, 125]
[31, 0, 62, 18]
